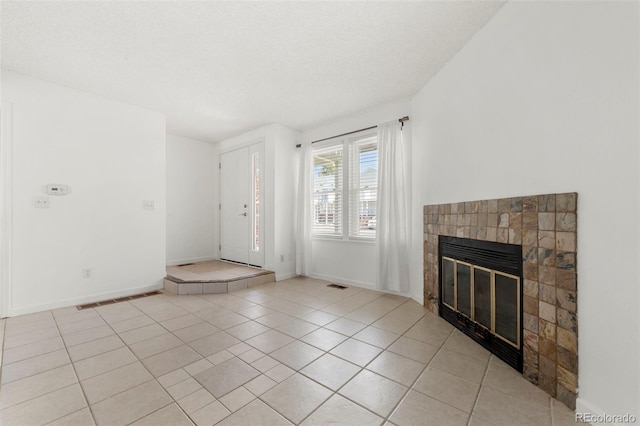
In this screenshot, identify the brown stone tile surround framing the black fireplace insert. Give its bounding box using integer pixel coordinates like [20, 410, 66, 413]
[424, 193, 578, 409]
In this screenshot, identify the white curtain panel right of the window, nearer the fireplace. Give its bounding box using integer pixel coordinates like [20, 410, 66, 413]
[376, 120, 411, 293]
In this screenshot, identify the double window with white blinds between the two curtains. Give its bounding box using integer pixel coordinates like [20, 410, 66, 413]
[313, 133, 378, 239]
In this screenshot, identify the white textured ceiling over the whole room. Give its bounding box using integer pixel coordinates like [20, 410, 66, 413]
[0, 1, 503, 142]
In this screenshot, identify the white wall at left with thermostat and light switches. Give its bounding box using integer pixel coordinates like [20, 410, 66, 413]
[2, 70, 165, 315]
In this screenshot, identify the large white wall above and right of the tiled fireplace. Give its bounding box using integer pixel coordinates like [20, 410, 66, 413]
[412, 2, 640, 416]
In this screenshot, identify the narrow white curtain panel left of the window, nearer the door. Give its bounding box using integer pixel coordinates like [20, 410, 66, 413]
[296, 144, 313, 275]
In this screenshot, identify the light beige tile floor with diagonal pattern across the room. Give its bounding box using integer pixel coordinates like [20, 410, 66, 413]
[0, 278, 574, 426]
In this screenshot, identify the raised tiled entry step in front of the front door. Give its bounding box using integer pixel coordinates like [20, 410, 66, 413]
[164, 260, 275, 294]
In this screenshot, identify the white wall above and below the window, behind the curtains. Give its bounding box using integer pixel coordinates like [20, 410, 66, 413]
[298, 100, 422, 292]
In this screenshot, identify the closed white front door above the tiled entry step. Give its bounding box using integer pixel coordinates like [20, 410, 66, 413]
[220, 144, 264, 267]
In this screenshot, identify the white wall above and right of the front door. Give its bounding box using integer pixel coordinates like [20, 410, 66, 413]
[216, 124, 298, 280]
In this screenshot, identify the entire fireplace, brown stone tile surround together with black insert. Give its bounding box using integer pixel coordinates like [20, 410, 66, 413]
[424, 193, 578, 408]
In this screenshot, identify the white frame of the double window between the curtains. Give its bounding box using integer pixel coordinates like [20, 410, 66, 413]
[311, 129, 378, 244]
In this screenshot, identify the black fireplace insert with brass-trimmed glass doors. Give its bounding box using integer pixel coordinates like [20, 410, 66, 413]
[438, 235, 523, 372]
